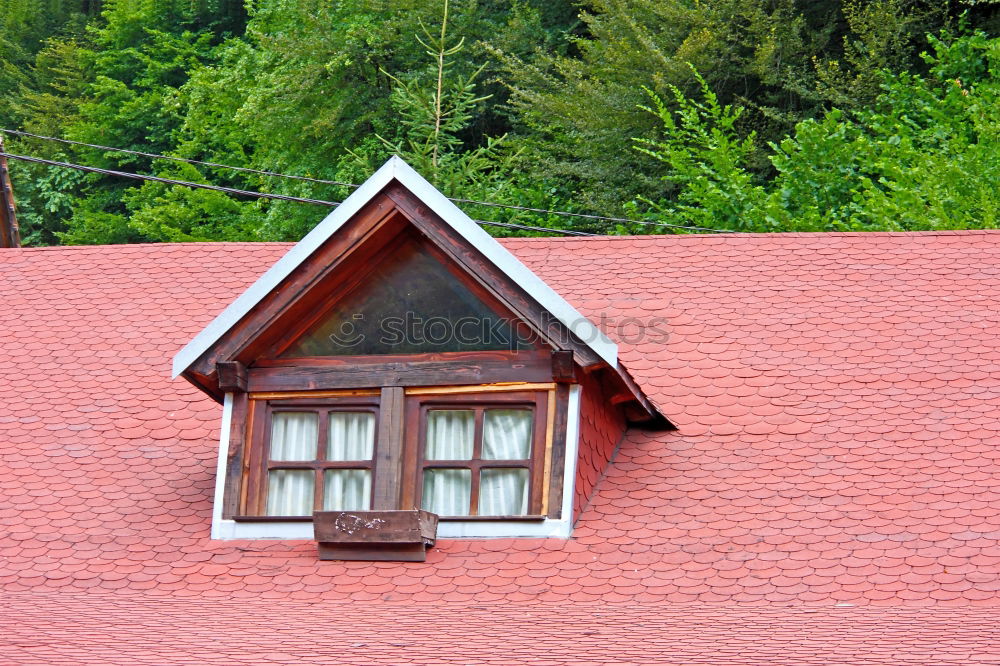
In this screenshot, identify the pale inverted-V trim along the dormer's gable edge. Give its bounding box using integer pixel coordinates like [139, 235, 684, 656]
[173, 156, 618, 377]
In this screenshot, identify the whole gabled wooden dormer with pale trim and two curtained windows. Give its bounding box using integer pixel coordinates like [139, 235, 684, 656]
[174, 158, 667, 539]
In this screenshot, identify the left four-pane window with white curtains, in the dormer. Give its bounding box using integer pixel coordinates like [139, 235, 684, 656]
[262, 402, 378, 517]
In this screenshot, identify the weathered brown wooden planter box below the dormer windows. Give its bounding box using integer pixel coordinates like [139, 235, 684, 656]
[313, 510, 438, 562]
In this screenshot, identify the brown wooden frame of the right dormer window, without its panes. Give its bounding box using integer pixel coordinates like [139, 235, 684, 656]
[403, 391, 551, 520]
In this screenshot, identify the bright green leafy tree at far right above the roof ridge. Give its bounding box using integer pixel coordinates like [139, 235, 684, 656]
[772, 32, 1000, 230]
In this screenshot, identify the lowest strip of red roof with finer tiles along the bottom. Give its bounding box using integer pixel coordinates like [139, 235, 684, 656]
[0, 592, 1000, 666]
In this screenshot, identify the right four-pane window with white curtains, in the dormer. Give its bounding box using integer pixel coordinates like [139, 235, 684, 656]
[417, 395, 545, 518]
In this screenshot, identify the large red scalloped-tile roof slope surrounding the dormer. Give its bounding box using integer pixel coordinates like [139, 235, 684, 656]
[0, 232, 1000, 663]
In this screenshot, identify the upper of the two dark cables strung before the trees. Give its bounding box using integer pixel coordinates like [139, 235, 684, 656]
[0, 128, 737, 236]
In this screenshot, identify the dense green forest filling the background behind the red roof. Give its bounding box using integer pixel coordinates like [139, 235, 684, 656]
[0, 0, 1000, 244]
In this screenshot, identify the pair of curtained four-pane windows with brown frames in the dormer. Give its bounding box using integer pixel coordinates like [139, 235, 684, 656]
[243, 384, 556, 521]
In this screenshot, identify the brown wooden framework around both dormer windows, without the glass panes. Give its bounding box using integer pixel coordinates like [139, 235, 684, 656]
[232, 383, 566, 522]
